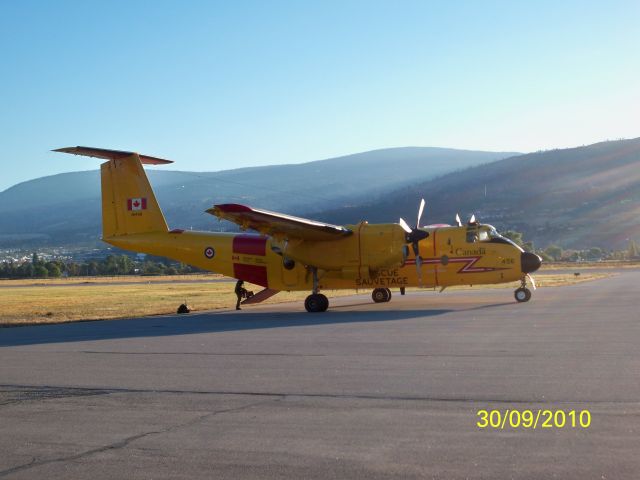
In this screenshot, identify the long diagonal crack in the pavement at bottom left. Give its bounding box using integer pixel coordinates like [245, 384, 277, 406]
[0, 395, 282, 477]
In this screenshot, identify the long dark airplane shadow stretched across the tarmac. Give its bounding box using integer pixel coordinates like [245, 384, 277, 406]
[0, 309, 460, 347]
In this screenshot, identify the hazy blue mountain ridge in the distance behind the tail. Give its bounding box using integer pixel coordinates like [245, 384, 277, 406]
[0, 147, 513, 247]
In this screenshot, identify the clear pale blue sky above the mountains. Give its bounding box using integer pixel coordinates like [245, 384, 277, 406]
[0, 0, 640, 190]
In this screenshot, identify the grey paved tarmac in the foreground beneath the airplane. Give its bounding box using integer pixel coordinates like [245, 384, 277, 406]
[0, 270, 640, 480]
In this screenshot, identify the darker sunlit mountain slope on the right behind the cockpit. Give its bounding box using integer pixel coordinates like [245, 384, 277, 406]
[319, 138, 640, 248]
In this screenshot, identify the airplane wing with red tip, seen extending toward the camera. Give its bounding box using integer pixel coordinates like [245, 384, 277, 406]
[207, 203, 353, 241]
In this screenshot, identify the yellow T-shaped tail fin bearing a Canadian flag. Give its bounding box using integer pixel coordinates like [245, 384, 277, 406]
[55, 147, 172, 239]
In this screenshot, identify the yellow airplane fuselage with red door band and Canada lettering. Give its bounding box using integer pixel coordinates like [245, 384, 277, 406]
[109, 222, 523, 291]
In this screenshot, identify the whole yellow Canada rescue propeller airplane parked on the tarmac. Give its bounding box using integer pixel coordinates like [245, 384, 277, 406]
[55, 147, 541, 312]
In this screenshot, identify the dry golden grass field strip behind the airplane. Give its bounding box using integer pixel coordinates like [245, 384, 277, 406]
[0, 271, 612, 326]
